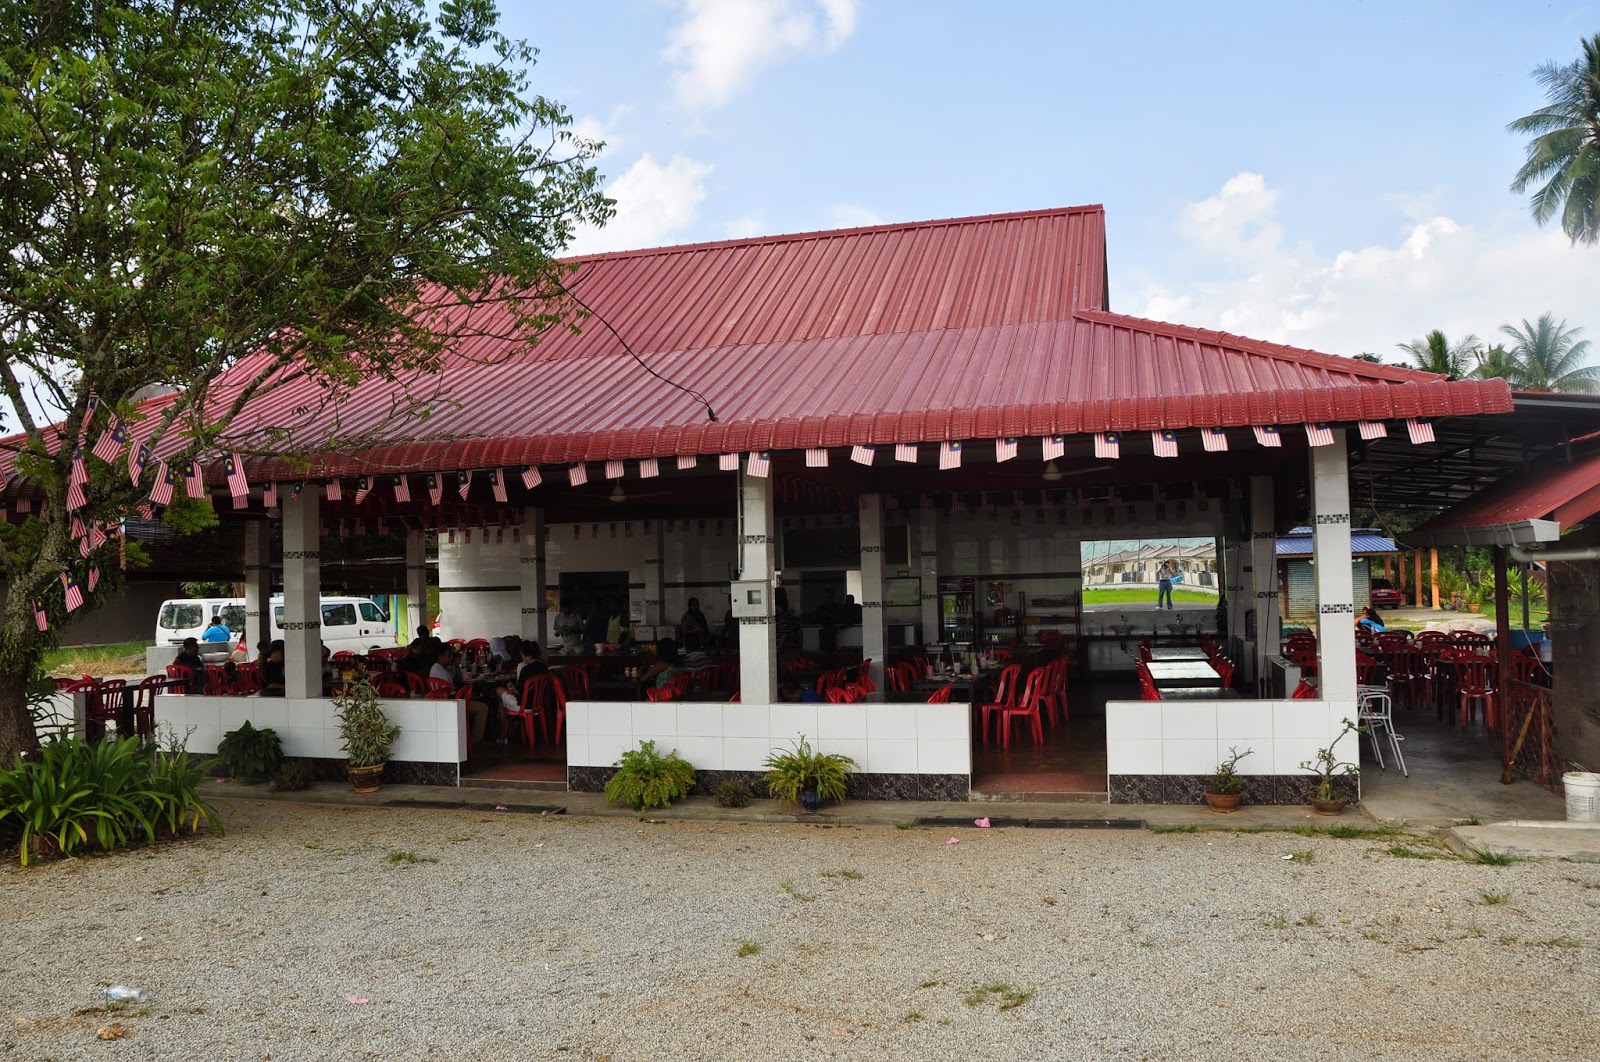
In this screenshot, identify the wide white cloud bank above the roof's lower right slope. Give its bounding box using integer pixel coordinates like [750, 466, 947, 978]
[1132, 173, 1600, 361]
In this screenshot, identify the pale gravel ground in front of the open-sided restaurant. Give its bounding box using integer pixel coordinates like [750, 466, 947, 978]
[0, 798, 1600, 1060]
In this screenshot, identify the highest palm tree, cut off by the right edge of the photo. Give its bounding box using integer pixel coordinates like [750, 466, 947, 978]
[1506, 34, 1600, 243]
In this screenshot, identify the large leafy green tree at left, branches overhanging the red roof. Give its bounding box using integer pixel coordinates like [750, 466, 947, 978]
[0, 0, 611, 763]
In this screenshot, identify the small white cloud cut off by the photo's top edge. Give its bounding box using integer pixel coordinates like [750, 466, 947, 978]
[662, 0, 858, 110]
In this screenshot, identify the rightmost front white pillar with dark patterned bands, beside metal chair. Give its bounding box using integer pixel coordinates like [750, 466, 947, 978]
[1310, 429, 1355, 701]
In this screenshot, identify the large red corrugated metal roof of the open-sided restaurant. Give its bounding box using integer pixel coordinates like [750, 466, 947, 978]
[0, 206, 1512, 480]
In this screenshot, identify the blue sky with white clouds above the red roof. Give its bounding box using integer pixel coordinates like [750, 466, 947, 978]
[501, 0, 1600, 361]
